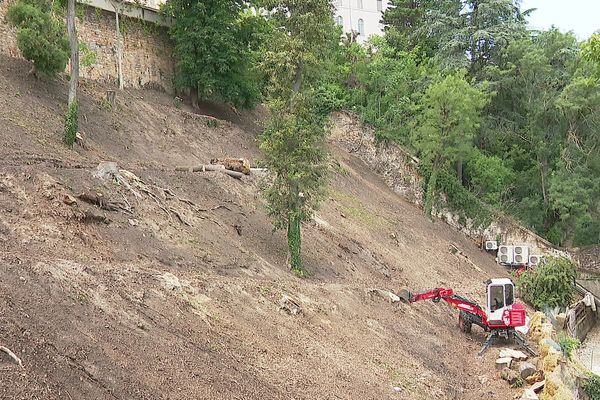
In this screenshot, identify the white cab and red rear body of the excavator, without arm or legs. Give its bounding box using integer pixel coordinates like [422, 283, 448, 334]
[486, 278, 525, 327]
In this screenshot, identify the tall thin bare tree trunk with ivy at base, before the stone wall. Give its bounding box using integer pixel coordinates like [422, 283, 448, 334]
[64, 0, 79, 146]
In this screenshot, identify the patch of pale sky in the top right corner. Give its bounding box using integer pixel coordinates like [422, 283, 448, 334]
[521, 0, 600, 40]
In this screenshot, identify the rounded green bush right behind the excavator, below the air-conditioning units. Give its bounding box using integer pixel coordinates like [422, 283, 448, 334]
[517, 257, 577, 310]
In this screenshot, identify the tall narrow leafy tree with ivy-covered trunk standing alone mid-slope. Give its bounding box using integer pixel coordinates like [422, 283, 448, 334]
[261, 0, 339, 275]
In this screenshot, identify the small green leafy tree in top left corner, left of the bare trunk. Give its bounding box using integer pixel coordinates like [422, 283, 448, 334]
[6, 0, 69, 79]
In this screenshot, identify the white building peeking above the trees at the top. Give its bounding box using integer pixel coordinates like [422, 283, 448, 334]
[333, 0, 389, 43]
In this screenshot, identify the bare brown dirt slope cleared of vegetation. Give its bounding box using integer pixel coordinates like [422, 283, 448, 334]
[0, 57, 514, 399]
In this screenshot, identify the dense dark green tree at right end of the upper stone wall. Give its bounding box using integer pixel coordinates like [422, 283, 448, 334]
[163, 0, 266, 107]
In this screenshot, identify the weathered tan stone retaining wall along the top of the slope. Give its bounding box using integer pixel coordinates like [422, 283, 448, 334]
[0, 0, 173, 92]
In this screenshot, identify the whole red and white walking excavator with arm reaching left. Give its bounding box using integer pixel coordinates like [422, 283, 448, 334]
[398, 278, 537, 356]
